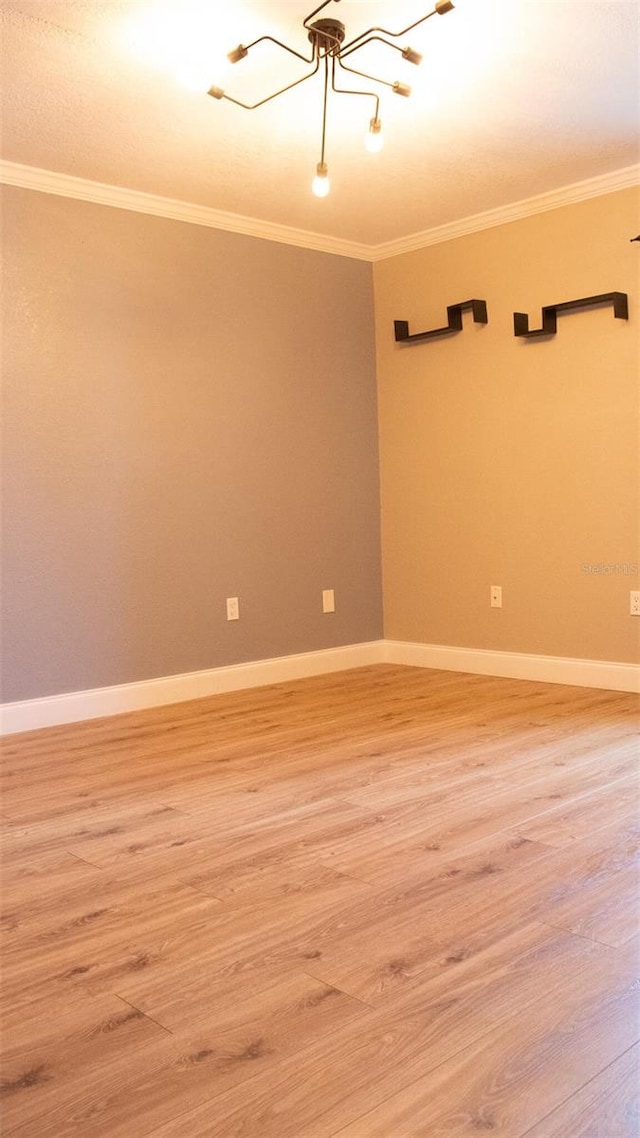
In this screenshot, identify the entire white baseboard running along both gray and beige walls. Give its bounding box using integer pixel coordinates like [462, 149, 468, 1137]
[0, 640, 640, 735]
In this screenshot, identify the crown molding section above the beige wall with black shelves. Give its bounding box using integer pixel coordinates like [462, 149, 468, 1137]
[369, 163, 640, 261]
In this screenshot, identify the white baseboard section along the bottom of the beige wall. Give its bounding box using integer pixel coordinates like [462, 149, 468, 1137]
[384, 641, 640, 692]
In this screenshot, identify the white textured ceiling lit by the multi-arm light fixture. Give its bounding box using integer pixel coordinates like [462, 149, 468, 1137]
[1, 0, 640, 245]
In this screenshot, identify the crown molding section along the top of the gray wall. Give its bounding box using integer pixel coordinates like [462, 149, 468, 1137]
[0, 160, 371, 261]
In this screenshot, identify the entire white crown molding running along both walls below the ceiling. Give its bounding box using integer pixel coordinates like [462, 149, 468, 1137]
[0, 160, 640, 262]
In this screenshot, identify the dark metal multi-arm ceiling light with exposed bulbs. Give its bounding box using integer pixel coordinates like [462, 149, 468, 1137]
[207, 0, 453, 198]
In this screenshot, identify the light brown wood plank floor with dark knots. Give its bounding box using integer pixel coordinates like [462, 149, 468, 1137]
[2, 666, 640, 1138]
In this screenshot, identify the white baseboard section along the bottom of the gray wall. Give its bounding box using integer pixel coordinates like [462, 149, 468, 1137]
[0, 641, 384, 735]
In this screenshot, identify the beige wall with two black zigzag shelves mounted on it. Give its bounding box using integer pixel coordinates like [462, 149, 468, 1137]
[375, 190, 640, 661]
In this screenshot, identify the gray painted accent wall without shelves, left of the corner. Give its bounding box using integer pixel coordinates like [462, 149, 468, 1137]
[2, 188, 383, 700]
